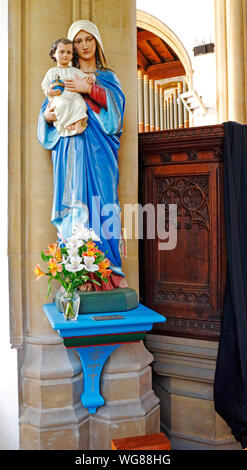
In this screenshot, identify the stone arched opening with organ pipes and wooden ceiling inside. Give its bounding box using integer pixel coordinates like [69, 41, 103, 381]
[137, 10, 192, 132]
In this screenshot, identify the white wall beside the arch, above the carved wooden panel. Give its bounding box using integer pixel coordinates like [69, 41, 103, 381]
[136, 0, 217, 125]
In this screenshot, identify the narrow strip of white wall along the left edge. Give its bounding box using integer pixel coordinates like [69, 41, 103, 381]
[0, 0, 19, 450]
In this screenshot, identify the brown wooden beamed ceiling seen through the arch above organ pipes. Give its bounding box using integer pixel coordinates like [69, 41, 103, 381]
[137, 28, 185, 80]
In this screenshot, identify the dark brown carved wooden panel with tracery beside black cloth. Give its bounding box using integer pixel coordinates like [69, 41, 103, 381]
[139, 125, 226, 340]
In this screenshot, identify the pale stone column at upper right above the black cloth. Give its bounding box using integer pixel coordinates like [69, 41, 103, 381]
[215, 0, 247, 124]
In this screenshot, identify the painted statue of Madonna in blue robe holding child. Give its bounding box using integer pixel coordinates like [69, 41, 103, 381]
[38, 20, 127, 290]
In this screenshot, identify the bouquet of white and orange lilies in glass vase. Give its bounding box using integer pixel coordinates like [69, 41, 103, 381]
[34, 225, 112, 320]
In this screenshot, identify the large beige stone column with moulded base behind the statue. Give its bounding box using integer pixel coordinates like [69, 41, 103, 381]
[9, 0, 159, 449]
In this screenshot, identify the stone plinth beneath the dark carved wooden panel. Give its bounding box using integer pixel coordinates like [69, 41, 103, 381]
[146, 334, 240, 450]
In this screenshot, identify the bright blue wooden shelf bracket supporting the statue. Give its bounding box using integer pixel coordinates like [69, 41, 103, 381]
[43, 303, 166, 413]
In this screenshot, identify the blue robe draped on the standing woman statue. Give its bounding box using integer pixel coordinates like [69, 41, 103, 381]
[38, 70, 125, 275]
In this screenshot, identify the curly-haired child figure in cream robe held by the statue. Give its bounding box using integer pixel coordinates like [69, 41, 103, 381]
[41, 38, 96, 137]
